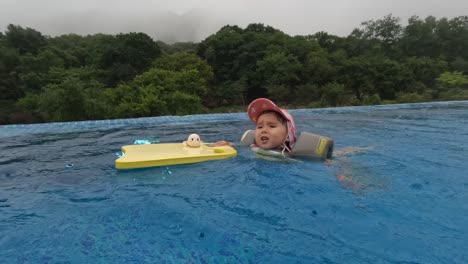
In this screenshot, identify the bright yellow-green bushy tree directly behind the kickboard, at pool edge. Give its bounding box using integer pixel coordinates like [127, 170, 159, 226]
[106, 68, 206, 118]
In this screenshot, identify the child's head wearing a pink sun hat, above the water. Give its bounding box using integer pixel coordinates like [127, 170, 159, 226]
[247, 98, 296, 152]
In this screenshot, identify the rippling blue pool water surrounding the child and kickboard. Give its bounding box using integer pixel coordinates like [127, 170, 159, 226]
[0, 101, 468, 263]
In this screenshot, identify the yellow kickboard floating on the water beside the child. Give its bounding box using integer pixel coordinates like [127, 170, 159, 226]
[115, 143, 237, 169]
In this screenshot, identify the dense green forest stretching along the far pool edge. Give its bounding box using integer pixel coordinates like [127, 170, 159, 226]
[0, 14, 468, 124]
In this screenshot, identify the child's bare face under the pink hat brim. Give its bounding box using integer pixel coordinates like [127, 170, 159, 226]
[255, 113, 288, 149]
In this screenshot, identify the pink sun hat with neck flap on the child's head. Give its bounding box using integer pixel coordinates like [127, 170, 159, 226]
[247, 98, 296, 147]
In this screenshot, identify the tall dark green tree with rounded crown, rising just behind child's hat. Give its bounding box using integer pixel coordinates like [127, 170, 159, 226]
[197, 24, 290, 101]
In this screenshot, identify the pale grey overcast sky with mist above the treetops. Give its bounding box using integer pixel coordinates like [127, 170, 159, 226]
[0, 0, 468, 43]
